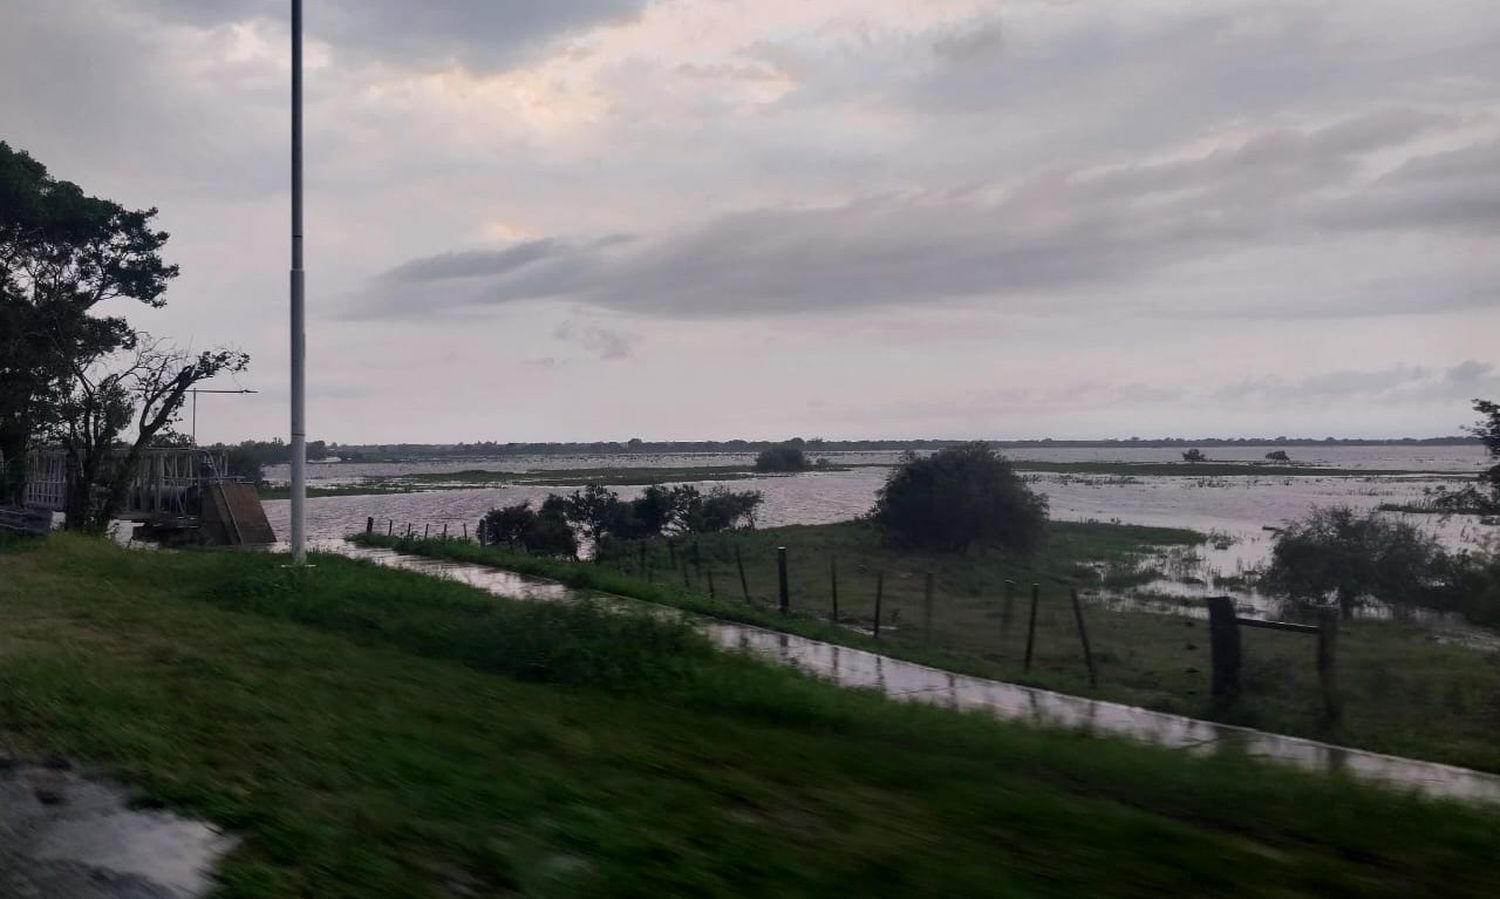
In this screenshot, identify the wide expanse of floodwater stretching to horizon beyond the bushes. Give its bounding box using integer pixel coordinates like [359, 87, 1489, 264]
[266, 444, 1497, 575]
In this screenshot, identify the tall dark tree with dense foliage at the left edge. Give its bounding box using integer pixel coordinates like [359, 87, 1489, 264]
[0, 143, 177, 503]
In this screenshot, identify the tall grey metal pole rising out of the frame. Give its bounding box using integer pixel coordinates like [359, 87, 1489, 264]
[291, 0, 308, 564]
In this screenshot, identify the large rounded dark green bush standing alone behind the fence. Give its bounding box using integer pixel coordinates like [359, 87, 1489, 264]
[870, 443, 1047, 552]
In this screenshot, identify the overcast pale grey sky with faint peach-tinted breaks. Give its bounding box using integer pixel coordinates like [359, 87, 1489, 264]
[0, 0, 1500, 443]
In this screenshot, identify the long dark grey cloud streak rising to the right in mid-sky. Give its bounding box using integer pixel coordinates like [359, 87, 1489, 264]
[366, 110, 1491, 317]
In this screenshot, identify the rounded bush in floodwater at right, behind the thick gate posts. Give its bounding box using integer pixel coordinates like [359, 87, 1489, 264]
[1262, 507, 1451, 617]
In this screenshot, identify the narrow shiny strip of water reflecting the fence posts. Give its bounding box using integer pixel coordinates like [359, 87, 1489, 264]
[318, 540, 1500, 803]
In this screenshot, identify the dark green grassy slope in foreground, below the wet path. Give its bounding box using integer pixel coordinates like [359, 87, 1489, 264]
[0, 536, 1500, 899]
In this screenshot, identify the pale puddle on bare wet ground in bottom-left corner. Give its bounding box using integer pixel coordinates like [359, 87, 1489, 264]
[0, 759, 234, 899]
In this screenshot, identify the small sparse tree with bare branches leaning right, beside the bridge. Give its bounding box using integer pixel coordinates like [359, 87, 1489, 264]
[54, 335, 249, 531]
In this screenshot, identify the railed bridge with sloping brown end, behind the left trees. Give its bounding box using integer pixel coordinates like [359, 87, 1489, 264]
[0, 447, 276, 546]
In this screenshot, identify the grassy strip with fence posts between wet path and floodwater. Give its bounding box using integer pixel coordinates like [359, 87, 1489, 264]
[362, 522, 1500, 771]
